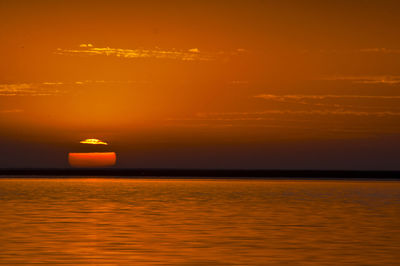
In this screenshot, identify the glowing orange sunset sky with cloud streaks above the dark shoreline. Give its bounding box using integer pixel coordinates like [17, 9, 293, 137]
[0, 0, 400, 170]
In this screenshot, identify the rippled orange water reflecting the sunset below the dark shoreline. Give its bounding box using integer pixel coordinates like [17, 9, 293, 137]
[0, 178, 400, 265]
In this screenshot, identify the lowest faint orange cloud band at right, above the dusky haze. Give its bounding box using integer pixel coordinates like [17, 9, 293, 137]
[167, 109, 400, 138]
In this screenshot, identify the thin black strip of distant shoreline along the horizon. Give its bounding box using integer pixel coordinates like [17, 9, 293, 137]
[0, 168, 400, 180]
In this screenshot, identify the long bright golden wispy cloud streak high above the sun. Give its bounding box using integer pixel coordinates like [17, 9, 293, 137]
[55, 44, 216, 61]
